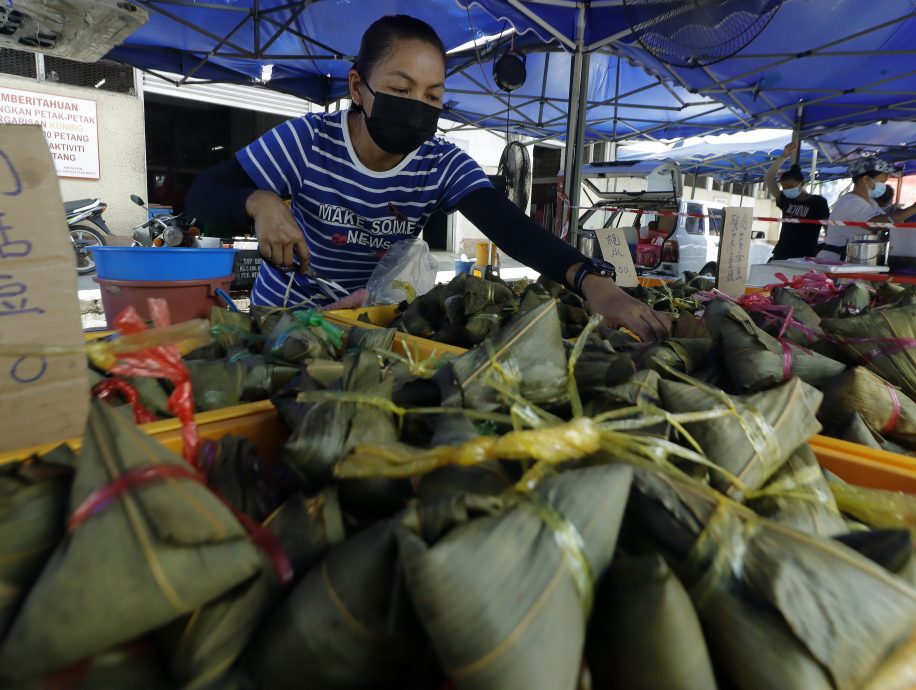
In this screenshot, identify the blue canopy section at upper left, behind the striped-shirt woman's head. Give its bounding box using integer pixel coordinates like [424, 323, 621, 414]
[108, 0, 508, 105]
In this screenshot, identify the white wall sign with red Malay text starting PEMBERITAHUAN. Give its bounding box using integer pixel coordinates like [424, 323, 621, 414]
[0, 87, 99, 180]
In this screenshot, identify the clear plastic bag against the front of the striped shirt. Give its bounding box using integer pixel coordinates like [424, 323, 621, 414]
[366, 238, 439, 304]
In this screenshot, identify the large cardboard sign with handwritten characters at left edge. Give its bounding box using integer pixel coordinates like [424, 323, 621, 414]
[0, 125, 89, 451]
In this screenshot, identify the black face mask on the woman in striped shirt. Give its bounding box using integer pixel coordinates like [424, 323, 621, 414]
[363, 80, 442, 156]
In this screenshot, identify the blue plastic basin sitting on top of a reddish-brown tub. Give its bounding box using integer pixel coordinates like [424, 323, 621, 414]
[87, 247, 238, 281]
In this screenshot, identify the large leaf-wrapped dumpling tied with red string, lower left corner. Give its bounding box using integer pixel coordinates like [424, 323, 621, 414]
[0, 402, 261, 679]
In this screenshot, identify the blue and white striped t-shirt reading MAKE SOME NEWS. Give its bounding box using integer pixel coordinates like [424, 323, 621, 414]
[236, 111, 490, 305]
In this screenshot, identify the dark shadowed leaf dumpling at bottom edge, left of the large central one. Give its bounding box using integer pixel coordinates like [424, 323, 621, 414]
[243, 520, 438, 690]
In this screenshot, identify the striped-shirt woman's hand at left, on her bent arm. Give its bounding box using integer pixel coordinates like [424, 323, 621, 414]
[245, 189, 311, 273]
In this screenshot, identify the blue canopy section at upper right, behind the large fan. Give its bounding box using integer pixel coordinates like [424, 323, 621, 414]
[458, 0, 916, 238]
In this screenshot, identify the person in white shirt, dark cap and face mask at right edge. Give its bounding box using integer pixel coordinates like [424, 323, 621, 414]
[817, 156, 916, 261]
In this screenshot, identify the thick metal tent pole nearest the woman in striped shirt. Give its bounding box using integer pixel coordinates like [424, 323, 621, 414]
[563, 2, 589, 246]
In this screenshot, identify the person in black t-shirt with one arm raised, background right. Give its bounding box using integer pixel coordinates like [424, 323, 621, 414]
[764, 142, 830, 261]
